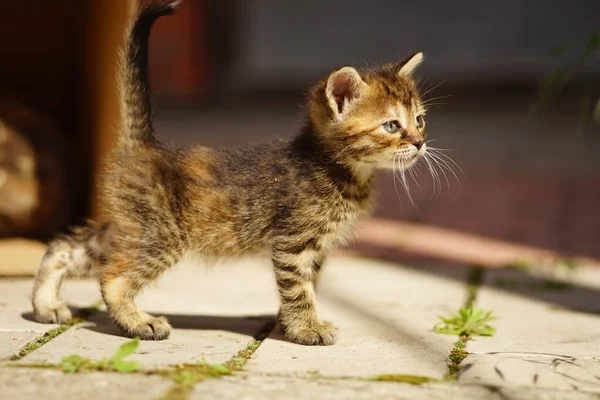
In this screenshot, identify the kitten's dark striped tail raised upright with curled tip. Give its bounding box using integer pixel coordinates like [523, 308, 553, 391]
[118, 0, 181, 147]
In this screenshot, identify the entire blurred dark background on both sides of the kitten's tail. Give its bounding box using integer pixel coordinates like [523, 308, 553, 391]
[0, 0, 600, 272]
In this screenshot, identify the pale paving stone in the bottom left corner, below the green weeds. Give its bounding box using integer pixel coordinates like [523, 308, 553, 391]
[0, 368, 172, 400]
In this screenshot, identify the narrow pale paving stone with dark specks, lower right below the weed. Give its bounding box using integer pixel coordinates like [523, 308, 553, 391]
[459, 354, 600, 393]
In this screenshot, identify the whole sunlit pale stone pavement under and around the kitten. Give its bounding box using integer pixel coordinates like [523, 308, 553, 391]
[0, 239, 600, 399]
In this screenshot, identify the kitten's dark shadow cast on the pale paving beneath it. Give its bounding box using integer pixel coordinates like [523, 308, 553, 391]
[22, 307, 287, 341]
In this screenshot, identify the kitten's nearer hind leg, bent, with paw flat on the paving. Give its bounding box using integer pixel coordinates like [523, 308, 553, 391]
[100, 250, 179, 340]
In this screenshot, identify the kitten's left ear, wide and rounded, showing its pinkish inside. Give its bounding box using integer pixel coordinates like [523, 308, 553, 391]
[325, 67, 367, 119]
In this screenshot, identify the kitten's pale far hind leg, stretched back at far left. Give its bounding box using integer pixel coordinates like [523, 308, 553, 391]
[32, 225, 110, 324]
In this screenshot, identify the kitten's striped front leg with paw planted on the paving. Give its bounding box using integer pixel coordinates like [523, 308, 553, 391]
[273, 249, 336, 345]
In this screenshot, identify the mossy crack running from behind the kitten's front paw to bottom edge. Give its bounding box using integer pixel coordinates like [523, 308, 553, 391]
[155, 319, 276, 400]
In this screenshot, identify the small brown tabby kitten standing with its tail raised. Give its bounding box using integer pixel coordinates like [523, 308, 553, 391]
[33, 1, 426, 345]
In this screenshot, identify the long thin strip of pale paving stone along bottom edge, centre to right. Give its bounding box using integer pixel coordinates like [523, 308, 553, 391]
[189, 374, 596, 400]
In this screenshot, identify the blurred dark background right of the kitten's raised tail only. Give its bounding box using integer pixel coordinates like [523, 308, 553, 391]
[146, 0, 600, 257]
